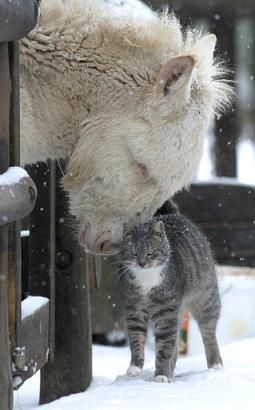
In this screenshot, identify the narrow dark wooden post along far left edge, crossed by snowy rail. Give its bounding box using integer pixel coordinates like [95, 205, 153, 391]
[0, 43, 12, 410]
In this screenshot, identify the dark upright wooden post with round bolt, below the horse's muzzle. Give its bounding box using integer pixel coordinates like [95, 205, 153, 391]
[40, 165, 92, 404]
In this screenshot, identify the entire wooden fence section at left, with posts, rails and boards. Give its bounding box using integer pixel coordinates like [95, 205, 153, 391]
[0, 0, 93, 410]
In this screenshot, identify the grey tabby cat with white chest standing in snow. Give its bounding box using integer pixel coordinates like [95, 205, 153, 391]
[117, 205, 222, 382]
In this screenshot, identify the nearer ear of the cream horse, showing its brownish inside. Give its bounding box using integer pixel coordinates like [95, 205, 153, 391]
[156, 55, 196, 104]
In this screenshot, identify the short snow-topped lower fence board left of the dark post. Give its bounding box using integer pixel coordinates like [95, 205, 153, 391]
[14, 300, 50, 389]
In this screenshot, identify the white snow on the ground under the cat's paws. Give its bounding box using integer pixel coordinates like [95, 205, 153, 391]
[14, 338, 255, 410]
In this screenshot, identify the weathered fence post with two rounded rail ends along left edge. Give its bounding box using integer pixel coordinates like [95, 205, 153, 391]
[0, 0, 37, 410]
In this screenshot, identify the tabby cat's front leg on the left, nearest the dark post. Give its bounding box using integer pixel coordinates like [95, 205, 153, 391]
[127, 311, 147, 377]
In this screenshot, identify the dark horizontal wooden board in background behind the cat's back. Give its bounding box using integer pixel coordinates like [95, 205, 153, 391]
[174, 179, 255, 267]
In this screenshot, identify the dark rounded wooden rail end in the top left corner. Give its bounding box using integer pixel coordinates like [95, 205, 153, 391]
[0, 0, 38, 42]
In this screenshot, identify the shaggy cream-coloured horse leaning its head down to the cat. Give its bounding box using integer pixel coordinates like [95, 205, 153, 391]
[20, 0, 230, 254]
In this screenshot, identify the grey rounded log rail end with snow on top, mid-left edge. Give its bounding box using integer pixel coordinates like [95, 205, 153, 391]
[0, 169, 37, 225]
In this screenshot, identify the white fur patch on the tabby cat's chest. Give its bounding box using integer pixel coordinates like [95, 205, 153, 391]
[132, 266, 163, 293]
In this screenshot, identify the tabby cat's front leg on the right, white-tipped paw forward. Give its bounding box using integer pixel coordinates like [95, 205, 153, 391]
[155, 312, 178, 383]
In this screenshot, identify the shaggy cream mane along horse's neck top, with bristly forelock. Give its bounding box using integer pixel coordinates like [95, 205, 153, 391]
[21, 0, 233, 112]
